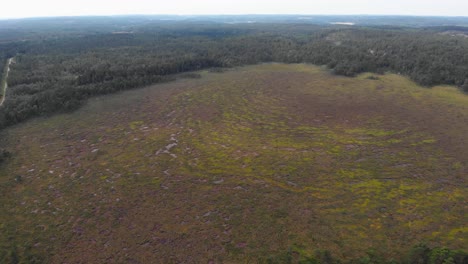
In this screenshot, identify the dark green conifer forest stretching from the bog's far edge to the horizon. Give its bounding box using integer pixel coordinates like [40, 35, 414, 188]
[0, 16, 468, 130]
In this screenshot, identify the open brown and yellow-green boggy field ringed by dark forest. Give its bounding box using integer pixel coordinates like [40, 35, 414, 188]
[0, 64, 468, 263]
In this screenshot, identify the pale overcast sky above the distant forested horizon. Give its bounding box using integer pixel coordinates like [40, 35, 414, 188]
[0, 0, 468, 18]
